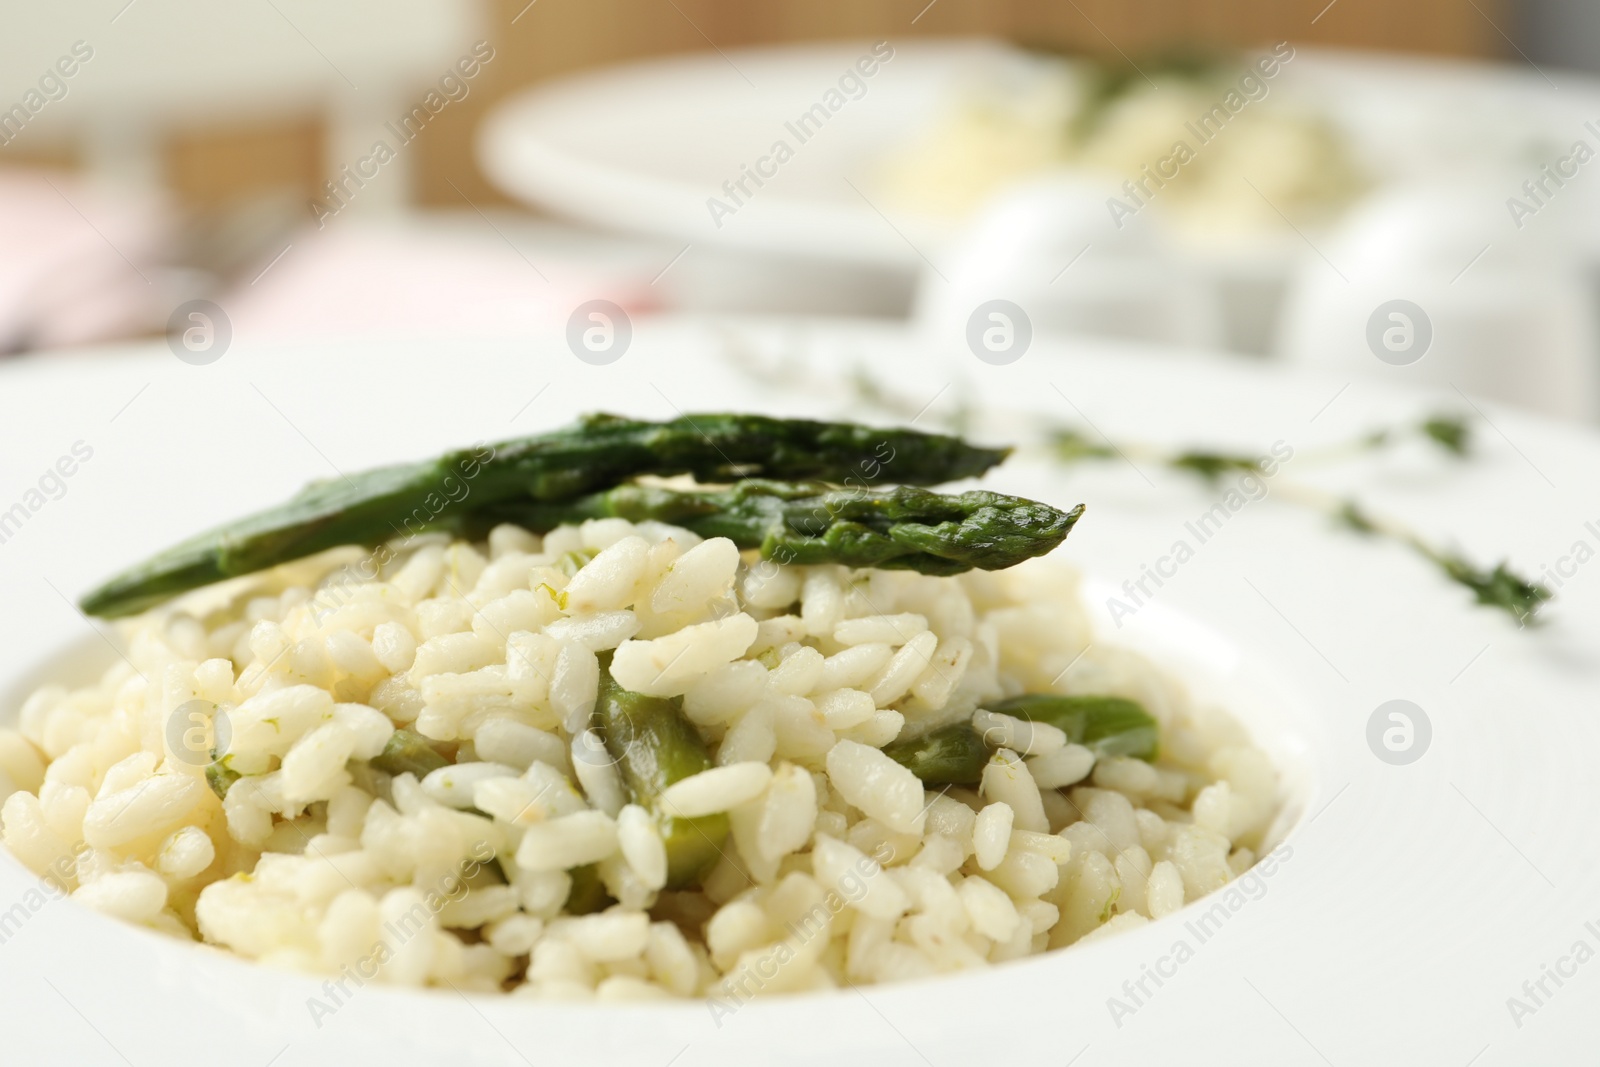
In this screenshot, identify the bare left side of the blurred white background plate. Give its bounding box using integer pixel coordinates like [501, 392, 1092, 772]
[478, 42, 1006, 269]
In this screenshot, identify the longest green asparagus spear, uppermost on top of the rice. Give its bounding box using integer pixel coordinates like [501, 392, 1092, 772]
[82, 414, 1010, 617]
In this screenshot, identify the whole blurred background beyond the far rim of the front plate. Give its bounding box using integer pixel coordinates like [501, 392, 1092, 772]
[0, 0, 1600, 419]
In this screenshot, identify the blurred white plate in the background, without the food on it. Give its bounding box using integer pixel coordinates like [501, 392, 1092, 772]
[478, 40, 1600, 277]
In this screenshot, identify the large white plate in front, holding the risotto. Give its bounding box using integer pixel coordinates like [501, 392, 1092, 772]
[0, 320, 1600, 1067]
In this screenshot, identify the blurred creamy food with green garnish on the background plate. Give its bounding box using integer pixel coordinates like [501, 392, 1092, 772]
[880, 43, 1365, 240]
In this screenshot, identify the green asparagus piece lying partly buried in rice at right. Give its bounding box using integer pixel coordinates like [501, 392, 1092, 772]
[883, 693, 1160, 785]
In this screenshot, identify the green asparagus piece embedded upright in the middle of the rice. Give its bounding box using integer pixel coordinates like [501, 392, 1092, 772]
[595, 653, 728, 889]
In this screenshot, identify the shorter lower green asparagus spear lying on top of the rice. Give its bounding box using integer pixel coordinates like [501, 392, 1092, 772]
[478, 478, 1083, 574]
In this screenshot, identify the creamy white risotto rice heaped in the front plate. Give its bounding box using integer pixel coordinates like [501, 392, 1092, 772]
[0, 520, 1277, 1001]
